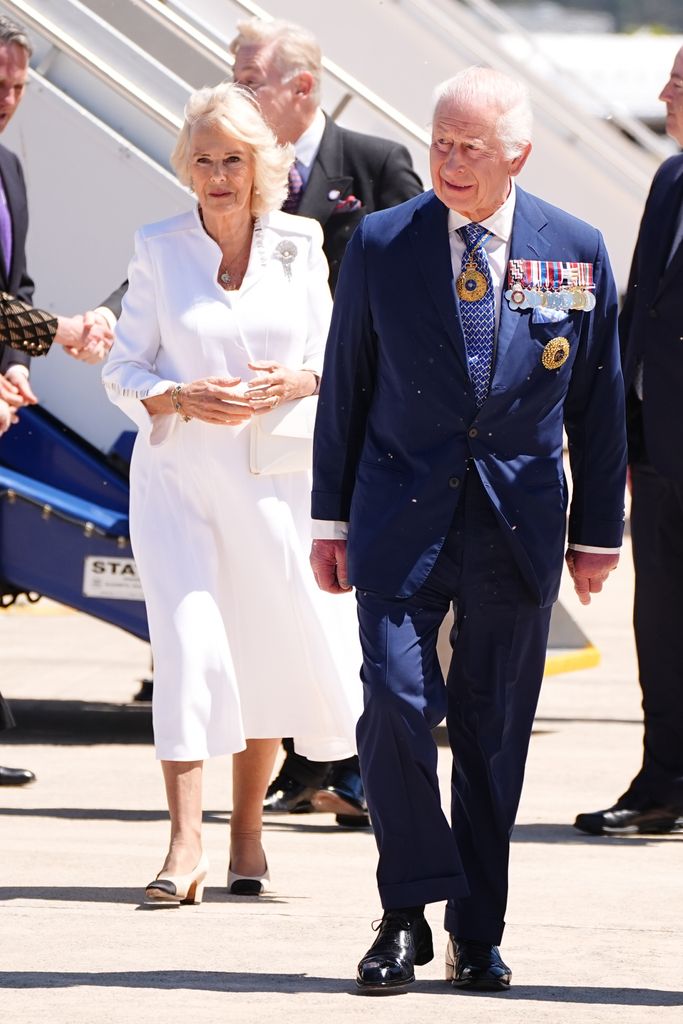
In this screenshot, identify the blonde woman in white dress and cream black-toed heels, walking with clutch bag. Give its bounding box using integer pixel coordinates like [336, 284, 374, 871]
[102, 84, 361, 902]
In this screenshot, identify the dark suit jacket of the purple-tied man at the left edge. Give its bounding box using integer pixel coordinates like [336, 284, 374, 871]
[0, 138, 34, 373]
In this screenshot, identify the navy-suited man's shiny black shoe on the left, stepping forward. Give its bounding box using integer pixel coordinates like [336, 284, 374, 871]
[355, 910, 434, 994]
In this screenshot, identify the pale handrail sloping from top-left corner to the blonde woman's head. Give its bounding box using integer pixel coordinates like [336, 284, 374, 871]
[2, 0, 181, 135]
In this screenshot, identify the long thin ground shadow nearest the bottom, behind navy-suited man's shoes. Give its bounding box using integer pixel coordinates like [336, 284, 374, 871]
[0, 971, 683, 1007]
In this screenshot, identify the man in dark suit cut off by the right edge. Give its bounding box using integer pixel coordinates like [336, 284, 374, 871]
[574, 48, 683, 836]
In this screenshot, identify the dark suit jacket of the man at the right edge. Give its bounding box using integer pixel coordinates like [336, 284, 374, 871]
[620, 156, 683, 480]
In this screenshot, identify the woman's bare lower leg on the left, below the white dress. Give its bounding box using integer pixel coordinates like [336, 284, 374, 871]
[161, 761, 203, 874]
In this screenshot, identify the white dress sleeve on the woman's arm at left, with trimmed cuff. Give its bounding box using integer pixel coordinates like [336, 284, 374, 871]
[102, 231, 177, 445]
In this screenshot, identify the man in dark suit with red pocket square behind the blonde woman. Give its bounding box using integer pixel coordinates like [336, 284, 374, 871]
[230, 17, 422, 825]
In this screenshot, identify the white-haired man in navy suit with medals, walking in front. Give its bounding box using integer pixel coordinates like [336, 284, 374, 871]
[311, 68, 626, 992]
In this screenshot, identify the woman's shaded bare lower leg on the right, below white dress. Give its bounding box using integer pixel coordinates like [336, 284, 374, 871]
[230, 738, 280, 878]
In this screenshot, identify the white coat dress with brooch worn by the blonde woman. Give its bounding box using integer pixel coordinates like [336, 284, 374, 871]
[102, 209, 362, 761]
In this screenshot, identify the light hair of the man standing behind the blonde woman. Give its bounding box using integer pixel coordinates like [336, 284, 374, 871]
[229, 17, 323, 102]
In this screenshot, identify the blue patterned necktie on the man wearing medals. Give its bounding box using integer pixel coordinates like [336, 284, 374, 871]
[459, 224, 496, 406]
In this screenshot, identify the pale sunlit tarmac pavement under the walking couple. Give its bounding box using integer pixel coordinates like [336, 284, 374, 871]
[0, 532, 683, 1024]
